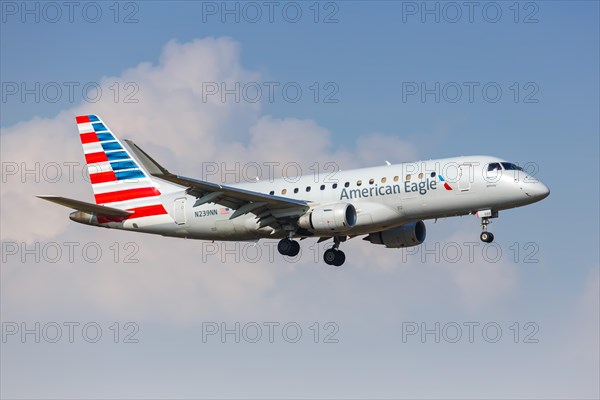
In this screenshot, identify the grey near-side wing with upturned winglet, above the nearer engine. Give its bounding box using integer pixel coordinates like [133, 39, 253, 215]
[125, 139, 310, 228]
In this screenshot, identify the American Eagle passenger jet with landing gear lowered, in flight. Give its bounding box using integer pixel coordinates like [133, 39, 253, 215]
[37, 114, 550, 267]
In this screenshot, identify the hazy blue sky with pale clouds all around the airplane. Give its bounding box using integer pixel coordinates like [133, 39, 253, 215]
[0, 1, 600, 398]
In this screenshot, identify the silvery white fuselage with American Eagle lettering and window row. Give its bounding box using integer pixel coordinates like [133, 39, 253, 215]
[105, 156, 549, 240]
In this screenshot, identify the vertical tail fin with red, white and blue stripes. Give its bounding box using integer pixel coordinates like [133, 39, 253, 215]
[76, 115, 167, 219]
